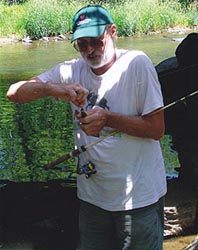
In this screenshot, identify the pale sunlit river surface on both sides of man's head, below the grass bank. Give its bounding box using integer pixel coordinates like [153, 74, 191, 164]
[0, 35, 182, 77]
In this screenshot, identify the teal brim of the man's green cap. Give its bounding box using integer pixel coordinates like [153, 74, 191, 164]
[71, 24, 106, 42]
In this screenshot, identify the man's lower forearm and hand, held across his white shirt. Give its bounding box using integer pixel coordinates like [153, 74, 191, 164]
[78, 107, 165, 140]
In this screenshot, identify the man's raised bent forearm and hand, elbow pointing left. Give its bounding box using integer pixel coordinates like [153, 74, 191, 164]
[7, 77, 88, 106]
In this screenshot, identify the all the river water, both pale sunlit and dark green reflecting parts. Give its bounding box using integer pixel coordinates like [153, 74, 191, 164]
[0, 32, 186, 181]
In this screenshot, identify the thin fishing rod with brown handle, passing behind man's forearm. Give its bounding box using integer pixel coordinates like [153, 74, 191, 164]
[45, 90, 198, 170]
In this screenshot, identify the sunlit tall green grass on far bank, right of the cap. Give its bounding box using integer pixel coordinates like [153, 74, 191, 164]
[110, 0, 187, 36]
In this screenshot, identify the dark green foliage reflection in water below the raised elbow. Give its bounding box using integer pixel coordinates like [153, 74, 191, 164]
[0, 77, 76, 182]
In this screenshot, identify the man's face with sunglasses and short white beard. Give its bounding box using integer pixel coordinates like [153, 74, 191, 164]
[73, 28, 115, 69]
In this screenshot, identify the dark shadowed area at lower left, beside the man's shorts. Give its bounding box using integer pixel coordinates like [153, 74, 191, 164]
[0, 181, 78, 250]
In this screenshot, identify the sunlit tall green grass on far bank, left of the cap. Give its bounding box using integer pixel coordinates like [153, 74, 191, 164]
[0, 0, 78, 39]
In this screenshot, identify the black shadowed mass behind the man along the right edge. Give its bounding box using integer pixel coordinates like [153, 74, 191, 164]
[156, 33, 198, 235]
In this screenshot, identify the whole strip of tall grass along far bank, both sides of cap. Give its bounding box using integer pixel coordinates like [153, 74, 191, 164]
[0, 0, 198, 39]
